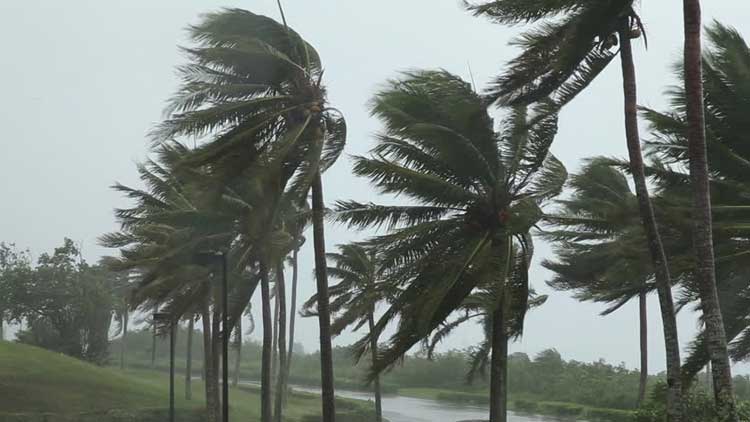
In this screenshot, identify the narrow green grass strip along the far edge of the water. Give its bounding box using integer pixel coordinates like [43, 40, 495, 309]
[398, 388, 635, 422]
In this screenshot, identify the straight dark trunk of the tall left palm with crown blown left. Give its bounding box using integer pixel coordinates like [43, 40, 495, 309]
[312, 172, 336, 422]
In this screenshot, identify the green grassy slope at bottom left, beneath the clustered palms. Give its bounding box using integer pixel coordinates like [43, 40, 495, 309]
[0, 342, 370, 422]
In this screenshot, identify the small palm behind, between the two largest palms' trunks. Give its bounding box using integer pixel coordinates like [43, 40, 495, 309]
[303, 243, 393, 422]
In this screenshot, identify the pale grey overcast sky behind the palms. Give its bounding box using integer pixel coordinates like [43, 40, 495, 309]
[0, 0, 750, 372]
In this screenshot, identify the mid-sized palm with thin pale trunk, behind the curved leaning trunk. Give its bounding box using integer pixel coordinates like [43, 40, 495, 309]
[543, 158, 654, 403]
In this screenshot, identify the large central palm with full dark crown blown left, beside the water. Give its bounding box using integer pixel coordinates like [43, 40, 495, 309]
[336, 71, 567, 422]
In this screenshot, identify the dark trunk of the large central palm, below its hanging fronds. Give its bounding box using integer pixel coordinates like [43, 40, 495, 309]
[490, 306, 508, 422]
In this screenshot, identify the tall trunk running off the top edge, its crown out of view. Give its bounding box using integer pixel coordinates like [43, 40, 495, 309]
[683, 0, 738, 422]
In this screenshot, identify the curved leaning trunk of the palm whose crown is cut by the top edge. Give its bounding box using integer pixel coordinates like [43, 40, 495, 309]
[619, 24, 683, 422]
